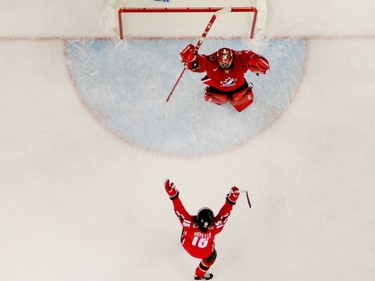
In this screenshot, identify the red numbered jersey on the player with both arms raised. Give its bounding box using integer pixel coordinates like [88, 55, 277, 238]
[172, 197, 233, 259]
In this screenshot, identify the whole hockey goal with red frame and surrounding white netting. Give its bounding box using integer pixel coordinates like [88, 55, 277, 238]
[107, 0, 266, 39]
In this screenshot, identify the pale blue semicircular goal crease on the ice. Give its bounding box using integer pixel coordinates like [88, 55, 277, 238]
[65, 39, 307, 156]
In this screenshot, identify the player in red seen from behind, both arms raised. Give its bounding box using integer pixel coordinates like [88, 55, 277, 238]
[165, 179, 240, 280]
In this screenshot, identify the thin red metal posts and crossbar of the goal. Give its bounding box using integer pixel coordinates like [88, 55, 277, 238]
[118, 7, 258, 40]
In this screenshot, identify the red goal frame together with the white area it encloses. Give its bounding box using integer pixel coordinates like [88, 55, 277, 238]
[117, 7, 258, 39]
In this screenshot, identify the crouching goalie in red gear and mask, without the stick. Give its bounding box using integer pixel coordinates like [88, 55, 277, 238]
[180, 44, 270, 112]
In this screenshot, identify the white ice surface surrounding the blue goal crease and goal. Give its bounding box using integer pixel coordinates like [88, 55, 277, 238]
[0, 0, 375, 281]
